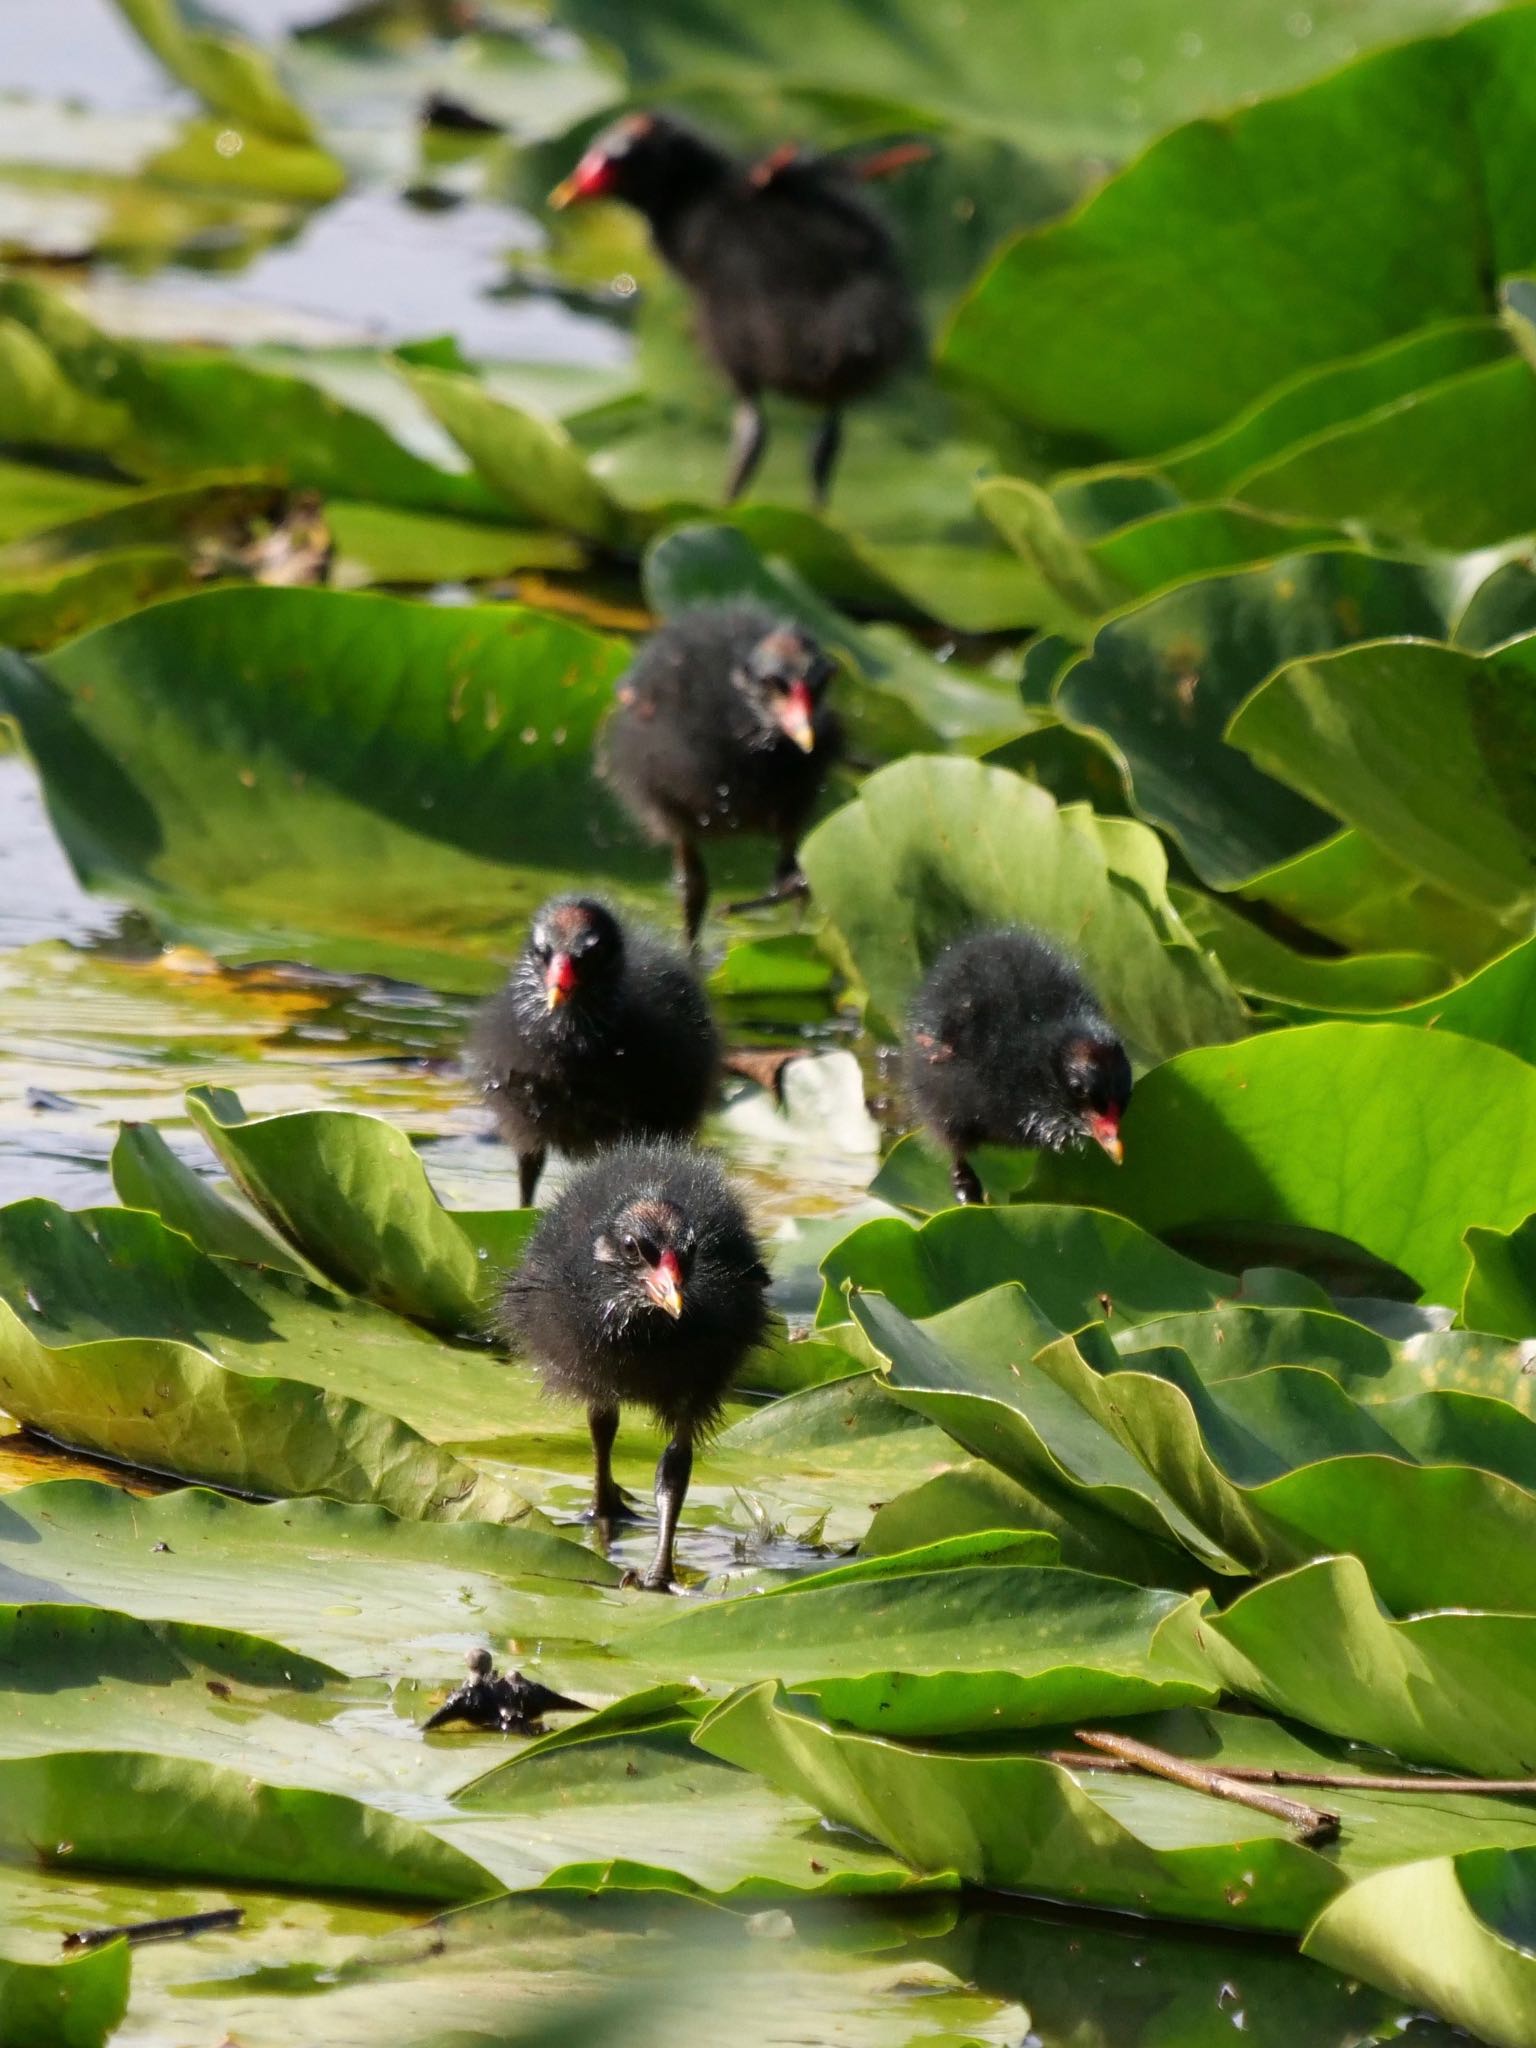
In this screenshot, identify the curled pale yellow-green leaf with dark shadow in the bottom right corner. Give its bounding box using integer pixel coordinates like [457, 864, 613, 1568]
[1303, 1849, 1536, 2048]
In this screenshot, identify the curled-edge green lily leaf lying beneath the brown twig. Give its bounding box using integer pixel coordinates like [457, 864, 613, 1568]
[694, 1683, 1536, 1933]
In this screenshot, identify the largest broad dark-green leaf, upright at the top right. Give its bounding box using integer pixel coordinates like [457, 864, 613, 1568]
[944, 10, 1536, 451]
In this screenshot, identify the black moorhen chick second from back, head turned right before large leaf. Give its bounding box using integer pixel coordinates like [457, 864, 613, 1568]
[602, 604, 842, 944]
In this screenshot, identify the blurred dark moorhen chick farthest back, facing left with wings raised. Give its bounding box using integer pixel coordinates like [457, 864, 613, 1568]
[549, 115, 928, 504]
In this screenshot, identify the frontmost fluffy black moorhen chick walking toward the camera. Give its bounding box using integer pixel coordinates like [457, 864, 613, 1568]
[500, 1145, 768, 1593]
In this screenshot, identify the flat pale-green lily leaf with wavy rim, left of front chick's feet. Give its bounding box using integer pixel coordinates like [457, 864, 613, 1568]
[0, 1479, 618, 1683]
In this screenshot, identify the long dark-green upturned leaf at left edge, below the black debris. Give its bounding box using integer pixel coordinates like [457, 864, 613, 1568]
[0, 1751, 496, 1901]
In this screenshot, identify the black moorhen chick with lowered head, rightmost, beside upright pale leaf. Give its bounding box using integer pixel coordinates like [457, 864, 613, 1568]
[907, 928, 1130, 1202]
